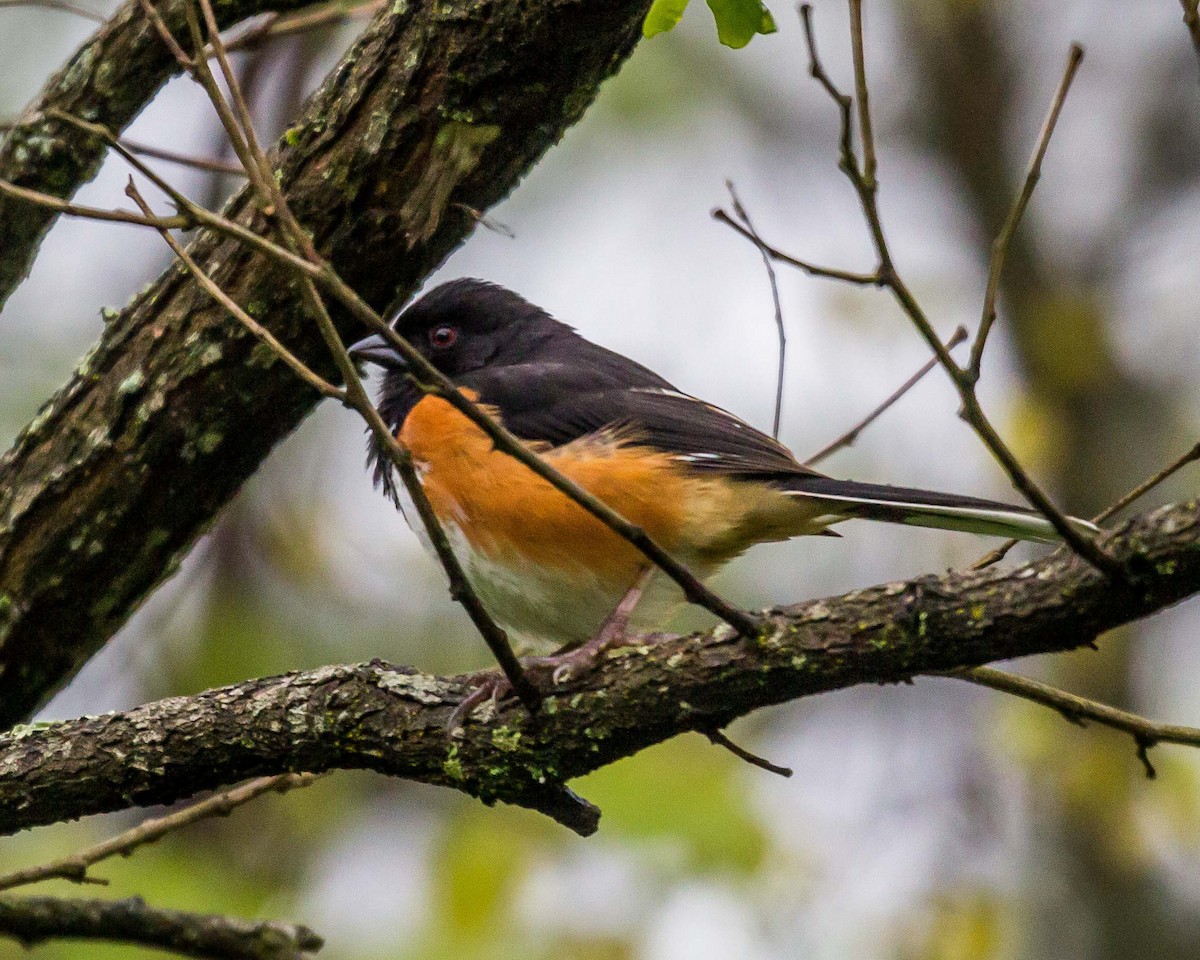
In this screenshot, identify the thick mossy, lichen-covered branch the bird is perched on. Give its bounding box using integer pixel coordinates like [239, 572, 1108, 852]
[0, 502, 1200, 833]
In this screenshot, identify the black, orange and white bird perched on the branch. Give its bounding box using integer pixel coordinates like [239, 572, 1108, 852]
[349, 278, 1094, 666]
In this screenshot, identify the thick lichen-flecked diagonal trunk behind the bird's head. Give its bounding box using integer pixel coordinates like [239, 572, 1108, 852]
[0, 0, 647, 726]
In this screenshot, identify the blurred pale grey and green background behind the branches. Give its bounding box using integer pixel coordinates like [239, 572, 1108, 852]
[0, 0, 1200, 960]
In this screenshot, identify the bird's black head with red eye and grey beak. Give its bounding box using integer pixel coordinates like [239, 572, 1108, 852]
[350, 280, 569, 383]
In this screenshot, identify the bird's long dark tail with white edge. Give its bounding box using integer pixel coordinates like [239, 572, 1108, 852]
[787, 476, 1097, 544]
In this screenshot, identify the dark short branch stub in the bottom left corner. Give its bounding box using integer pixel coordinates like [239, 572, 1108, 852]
[0, 896, 323, 960]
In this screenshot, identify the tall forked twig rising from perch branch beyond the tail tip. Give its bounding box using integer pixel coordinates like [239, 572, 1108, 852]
[800, 0, 1123, 576]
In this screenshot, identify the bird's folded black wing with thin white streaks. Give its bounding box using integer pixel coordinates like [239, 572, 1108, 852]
[458, 358, 820, 478]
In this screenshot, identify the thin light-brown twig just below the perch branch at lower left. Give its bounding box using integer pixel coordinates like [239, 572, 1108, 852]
[0, 773, 318, 890]
